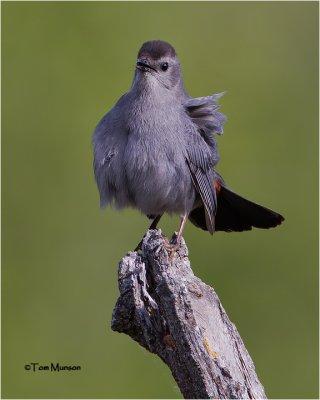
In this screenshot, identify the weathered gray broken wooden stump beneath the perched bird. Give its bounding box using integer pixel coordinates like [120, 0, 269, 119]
[112, 230, 266, 399]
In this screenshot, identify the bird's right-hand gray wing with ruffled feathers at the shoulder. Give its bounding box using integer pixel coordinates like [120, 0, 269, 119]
[184, 93, 226, 233]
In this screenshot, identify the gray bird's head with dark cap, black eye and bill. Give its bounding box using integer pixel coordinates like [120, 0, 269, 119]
[136, 40, 181, 90]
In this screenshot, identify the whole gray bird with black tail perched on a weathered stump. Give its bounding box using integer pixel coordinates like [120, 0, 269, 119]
[92, 40, 284, 251]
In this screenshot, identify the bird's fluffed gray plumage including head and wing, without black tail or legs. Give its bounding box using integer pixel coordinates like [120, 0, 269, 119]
[93, 41, 225, 233]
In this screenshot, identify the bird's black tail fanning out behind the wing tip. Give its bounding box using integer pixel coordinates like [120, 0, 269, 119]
[189, 180, 284, 232]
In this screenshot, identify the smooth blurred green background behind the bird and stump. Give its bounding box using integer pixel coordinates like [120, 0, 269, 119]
[1, 2, 318, 398]
